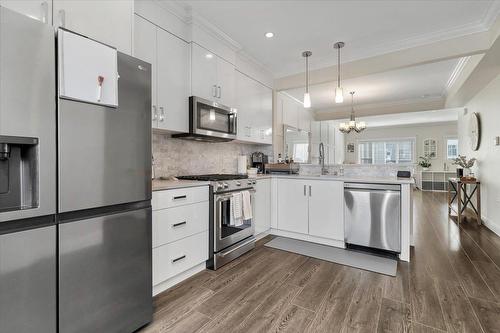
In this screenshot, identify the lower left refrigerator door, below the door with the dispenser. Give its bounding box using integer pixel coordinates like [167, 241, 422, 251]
[0, 226, 57, 333]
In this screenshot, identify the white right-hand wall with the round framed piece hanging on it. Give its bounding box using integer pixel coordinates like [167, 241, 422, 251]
[458, 75, 500, 235]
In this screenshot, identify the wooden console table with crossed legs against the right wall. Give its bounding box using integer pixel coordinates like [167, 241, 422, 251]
[448, 178, 481, 226]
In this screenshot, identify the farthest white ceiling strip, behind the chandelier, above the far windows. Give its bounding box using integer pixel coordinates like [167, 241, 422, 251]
[350, 109, 463, 128]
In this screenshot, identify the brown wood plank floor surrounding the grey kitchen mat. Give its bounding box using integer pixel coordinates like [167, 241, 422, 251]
[140, 191, 500, 333]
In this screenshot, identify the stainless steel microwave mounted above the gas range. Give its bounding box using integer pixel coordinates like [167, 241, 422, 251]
[172, 96, 238, 142]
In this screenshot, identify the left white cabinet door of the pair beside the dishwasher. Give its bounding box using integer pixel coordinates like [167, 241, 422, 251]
[278, 179, 309, 234]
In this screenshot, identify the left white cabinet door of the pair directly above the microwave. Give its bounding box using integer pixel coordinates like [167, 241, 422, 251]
[191, 43, 217, 101]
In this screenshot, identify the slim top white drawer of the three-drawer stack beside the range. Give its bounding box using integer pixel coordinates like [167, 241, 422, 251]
[151, 186, 208, 210]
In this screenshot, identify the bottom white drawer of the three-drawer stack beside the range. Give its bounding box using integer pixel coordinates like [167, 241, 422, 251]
[153, 231, 208, 285]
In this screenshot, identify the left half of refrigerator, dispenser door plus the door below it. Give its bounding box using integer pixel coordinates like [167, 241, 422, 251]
[0, 6, 57, 333]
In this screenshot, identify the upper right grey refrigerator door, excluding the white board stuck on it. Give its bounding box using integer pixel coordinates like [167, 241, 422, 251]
[58, 53, 151, 212]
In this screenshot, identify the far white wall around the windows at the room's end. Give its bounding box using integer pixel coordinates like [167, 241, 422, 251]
[344, 122, 457, 170]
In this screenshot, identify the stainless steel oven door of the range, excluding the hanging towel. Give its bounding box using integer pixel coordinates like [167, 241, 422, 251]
[214, 189, 255, 252]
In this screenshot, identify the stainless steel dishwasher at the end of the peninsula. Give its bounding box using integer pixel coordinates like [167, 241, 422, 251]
[344, 183, 401, 253]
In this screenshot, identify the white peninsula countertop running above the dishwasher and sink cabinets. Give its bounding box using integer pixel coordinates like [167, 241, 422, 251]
[257, 174, 415, 184]
